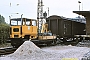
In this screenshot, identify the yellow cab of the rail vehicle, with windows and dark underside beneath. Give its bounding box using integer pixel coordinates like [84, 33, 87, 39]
[10, 18, 37, 46]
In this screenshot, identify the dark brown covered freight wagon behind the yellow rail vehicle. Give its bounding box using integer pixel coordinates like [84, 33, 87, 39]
[46, 15, 86, 41]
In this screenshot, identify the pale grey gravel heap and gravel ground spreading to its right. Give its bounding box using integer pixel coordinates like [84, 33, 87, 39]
[0, 41, 90, 60]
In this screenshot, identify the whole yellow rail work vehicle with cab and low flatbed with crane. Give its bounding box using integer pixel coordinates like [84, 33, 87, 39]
[9, 18, 57, 47]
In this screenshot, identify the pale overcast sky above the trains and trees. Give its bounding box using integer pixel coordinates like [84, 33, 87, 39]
[0, 0, 90, 22]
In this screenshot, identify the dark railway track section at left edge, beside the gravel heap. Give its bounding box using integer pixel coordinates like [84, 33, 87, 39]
[0, 47, 17, 56]
